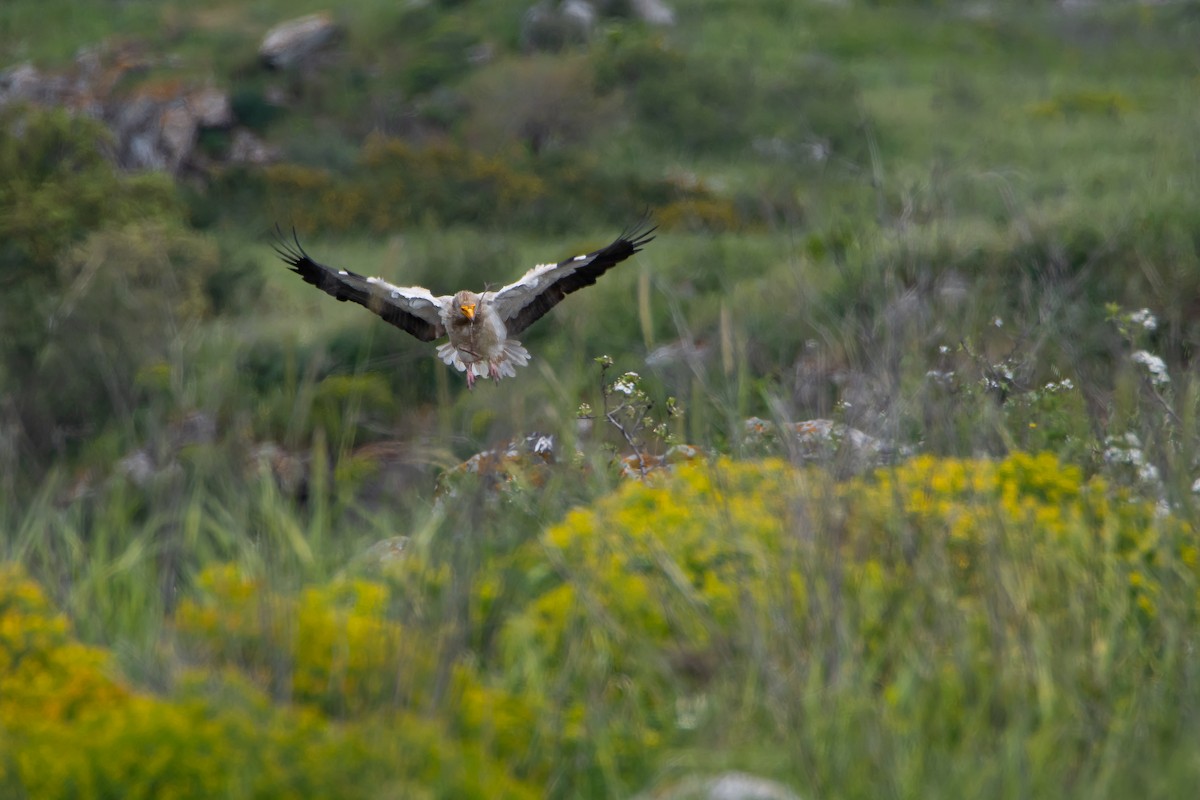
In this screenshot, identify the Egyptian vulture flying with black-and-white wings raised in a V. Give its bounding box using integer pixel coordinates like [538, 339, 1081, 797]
[275, 221, 655, 389]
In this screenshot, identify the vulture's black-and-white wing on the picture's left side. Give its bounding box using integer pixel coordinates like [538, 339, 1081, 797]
[275, 225, 449, 342]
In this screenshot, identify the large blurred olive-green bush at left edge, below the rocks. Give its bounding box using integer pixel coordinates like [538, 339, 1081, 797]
[0, 109, 208, 465]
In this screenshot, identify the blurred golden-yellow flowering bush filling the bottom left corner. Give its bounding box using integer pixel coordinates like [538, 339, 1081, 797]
[0, 566, 534, 800]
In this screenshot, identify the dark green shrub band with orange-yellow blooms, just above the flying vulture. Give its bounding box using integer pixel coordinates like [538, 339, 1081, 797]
[219, 131, 742, 234]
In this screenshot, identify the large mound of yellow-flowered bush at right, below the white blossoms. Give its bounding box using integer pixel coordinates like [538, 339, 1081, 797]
[480, 453, 1200, 794]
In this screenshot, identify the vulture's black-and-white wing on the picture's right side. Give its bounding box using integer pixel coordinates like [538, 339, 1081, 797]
[492, 219, 655, 336]
